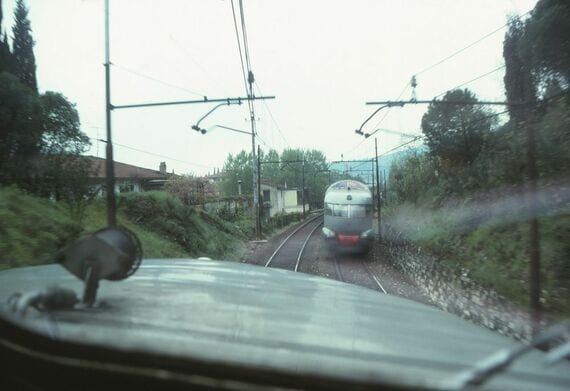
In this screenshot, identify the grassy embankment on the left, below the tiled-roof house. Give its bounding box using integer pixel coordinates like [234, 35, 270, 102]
[0, 187, 245, 269]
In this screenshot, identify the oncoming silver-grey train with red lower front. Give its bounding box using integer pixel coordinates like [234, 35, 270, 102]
[322, 179, 374, 251]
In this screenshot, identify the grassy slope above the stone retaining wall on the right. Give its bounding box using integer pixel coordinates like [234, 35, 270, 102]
[386, 203, 570, 318]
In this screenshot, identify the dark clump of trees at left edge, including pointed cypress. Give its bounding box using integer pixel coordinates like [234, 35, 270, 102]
[0, 0, 91, 207]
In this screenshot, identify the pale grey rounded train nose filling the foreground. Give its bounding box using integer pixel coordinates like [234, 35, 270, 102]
[0, 259, 570, 389]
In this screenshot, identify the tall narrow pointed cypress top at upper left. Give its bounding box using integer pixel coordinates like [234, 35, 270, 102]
[12, 0, 38, 92]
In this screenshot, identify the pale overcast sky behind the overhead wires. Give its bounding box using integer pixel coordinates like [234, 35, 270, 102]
[3, 0, 536, 174]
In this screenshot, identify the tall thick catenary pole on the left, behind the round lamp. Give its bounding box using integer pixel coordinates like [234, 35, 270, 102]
[105, 0, 117, 227]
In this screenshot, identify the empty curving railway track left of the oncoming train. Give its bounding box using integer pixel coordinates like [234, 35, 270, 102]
[265, 214, 323, 271]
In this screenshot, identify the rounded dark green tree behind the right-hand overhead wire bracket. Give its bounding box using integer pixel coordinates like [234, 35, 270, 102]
[421, 89, 496, 168]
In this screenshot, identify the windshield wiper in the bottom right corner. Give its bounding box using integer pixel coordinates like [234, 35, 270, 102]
[446, 320, 570, 390]
